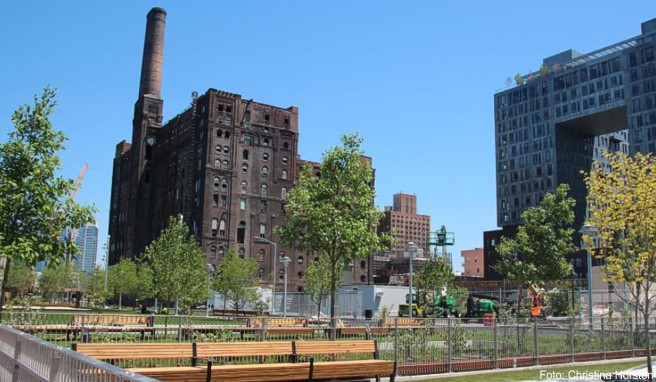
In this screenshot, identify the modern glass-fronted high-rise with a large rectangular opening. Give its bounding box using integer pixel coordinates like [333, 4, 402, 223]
[484, 19, 656, 278]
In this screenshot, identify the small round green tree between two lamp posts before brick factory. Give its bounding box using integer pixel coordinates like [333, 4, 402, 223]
[212, 249, 260, 312]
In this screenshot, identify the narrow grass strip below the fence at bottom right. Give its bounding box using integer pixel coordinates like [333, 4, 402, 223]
[416, 360, 645, 382]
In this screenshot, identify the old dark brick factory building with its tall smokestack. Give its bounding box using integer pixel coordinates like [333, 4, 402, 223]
[109, 8, 368, 291]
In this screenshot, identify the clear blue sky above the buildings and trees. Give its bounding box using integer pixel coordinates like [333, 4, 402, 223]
[0, 0, 656, 269]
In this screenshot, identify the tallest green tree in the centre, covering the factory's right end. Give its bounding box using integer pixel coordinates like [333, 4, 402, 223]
[278, 134, 387, 319]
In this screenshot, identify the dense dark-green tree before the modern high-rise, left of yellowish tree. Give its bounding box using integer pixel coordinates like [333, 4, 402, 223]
[497, 184, 577, 313]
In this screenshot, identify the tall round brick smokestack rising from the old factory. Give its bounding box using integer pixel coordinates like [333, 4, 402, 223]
[139, 8, 166, 98]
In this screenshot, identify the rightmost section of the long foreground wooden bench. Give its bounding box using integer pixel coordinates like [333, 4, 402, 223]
[294, 340, 396, 382]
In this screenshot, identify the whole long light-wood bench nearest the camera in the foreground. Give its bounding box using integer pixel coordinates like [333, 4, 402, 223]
[82, 340, 396, 382]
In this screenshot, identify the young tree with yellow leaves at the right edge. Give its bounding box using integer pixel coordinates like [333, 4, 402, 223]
[584, 152, 656, 375]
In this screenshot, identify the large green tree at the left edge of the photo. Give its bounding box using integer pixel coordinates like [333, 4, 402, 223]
[0, 88, 95, 312]
